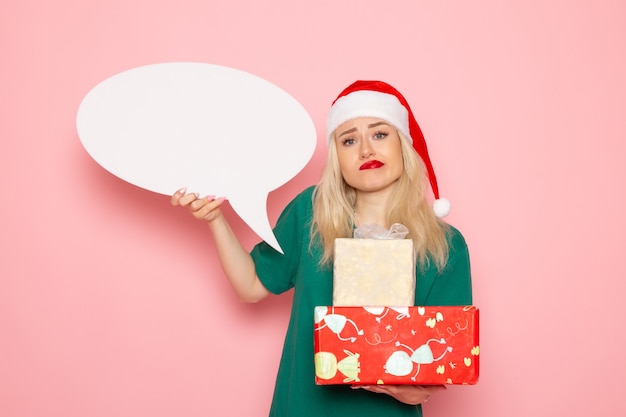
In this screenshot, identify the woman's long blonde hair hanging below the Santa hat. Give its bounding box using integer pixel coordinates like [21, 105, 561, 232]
[311, 132, 448, 270]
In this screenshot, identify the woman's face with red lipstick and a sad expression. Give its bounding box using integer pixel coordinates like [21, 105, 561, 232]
[335, 117, 404, 192]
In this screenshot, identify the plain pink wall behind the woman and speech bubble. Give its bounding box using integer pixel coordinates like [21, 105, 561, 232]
[0, 0, 626, 417]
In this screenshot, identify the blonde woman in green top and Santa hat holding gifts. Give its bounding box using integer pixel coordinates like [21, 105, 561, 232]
[171, 81, 472, 417]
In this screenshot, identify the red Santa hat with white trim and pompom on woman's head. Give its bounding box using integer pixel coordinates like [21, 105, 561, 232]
[326, 81, 450, 217]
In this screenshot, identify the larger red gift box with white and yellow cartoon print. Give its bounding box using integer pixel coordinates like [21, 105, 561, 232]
[314, 306, 480, 385]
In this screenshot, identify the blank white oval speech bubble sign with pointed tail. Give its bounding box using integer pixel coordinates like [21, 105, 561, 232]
[76, 62, 317, 253]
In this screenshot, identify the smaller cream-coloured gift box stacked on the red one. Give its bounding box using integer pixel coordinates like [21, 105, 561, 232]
[333, 238, 415, 306]
